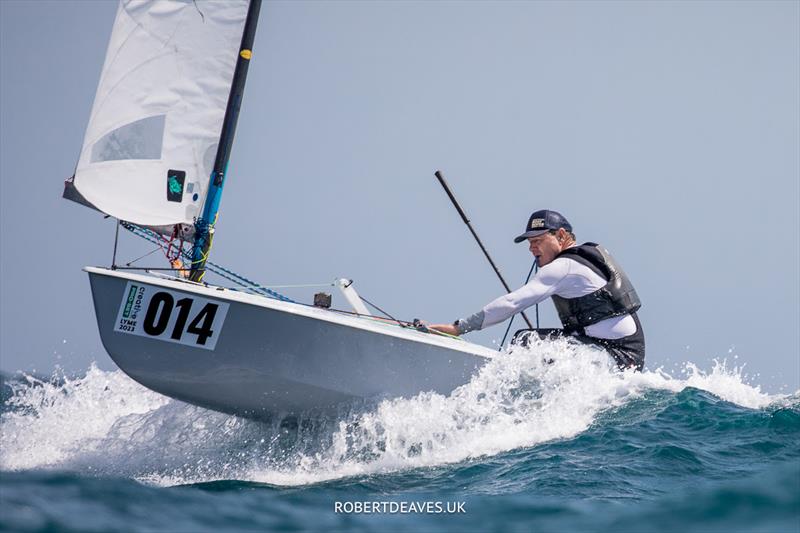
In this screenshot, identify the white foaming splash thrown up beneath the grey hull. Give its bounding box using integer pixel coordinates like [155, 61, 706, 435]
[0, 339, 794, 486]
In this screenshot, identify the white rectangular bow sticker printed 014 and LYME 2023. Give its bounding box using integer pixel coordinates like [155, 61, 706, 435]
[114, 281, 228, 350]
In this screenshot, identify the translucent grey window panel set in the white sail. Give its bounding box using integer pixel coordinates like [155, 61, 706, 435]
[92, 115, 166, 163]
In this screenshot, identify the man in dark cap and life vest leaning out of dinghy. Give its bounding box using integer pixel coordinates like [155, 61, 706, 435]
[428, 209, 644, 370]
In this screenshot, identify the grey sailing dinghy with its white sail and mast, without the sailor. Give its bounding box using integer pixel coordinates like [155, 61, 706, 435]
[64, 0, 496, 418]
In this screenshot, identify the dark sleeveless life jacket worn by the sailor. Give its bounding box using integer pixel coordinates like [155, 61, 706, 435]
[552, 242, 642, 333]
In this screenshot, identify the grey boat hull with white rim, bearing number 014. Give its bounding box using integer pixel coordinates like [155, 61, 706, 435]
[86, 267, 494, 418]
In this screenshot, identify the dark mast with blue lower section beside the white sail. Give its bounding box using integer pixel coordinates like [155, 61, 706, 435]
[189, 0, 261, 282]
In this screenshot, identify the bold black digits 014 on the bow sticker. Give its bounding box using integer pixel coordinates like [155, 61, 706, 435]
[142, 292, 219, 346]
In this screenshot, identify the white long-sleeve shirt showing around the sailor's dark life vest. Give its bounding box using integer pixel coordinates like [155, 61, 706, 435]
[461, 257, 636, 339]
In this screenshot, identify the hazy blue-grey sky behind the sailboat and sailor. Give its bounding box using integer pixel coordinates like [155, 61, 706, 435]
[0, 0, 800, 391]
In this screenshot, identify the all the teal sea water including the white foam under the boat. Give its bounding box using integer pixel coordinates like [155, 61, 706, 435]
[0, 341, 800, 532]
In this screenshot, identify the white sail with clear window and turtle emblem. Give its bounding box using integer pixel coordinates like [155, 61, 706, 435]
[72, 0, 248, 226]
